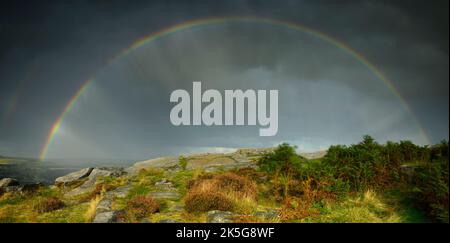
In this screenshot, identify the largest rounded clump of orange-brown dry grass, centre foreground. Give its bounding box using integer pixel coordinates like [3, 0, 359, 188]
[184, 172, 257, 213]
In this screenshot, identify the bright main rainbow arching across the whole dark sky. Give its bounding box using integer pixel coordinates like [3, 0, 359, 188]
[40, 17, 430, 160]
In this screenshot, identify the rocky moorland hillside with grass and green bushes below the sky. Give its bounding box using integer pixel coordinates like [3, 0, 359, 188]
[0, 141, 448, 222]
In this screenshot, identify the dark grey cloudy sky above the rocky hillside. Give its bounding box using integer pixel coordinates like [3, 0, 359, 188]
[0, 0, 449, 159]
